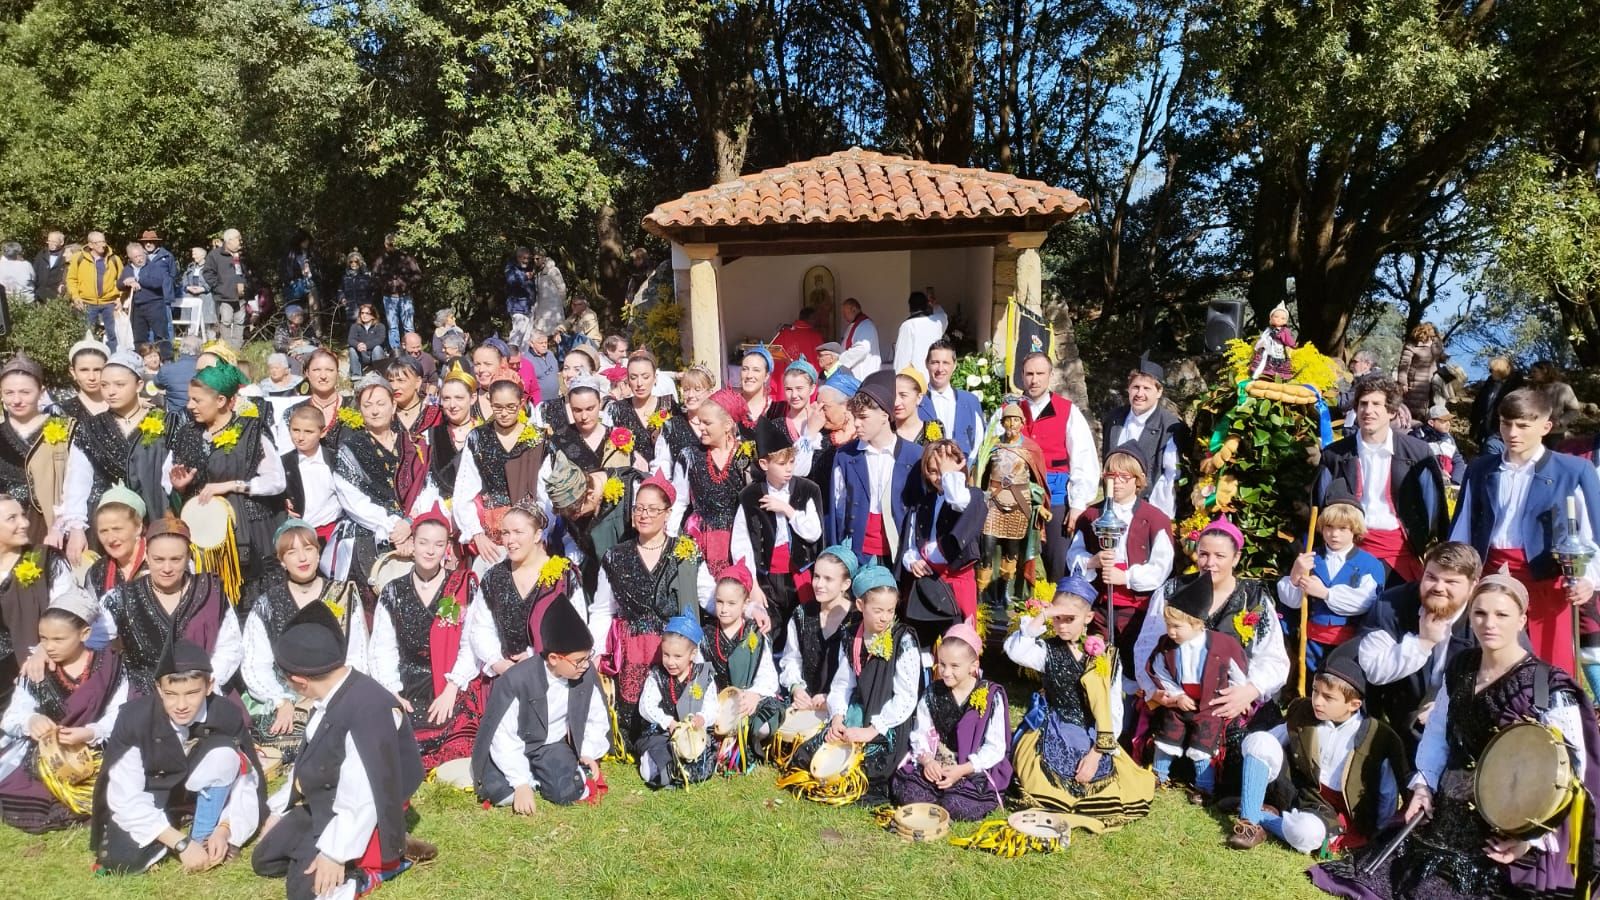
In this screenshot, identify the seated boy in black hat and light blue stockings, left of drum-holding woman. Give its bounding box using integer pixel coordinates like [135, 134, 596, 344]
[1227, 642, 1413, 854]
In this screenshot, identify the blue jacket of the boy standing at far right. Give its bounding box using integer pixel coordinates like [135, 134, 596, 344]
[1456, 450, 1600, 580]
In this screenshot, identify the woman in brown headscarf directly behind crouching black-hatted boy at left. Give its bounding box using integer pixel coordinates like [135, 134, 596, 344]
[90, 516, 243, 697]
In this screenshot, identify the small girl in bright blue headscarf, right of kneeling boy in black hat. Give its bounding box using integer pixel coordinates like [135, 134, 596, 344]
[638, 615, 717, 788]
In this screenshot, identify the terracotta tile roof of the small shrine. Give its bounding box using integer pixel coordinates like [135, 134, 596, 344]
[645, 147, 1088, 234]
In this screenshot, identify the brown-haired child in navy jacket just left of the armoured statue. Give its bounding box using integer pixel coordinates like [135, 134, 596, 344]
[901, 439, 989, 637]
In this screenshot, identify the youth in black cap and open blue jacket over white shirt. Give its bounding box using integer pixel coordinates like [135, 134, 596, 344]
[813, 372, 925, 569]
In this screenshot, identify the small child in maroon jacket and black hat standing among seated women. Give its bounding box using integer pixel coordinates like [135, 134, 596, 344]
[1147, 573, 1248, 796]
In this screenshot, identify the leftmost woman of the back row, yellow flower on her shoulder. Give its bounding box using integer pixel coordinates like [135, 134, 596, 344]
[0, 354, 71, 548]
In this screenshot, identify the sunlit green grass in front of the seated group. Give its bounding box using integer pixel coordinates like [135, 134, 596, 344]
[0, 765, 1318, 900]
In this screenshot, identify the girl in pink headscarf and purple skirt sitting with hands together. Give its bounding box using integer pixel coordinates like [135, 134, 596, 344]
[893, 623, 1011, 822]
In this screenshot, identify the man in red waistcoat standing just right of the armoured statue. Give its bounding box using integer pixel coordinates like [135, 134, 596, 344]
[1021, 352, 1099, 583]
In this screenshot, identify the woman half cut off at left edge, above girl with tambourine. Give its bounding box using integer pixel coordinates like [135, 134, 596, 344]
[0, 493, 77, 705]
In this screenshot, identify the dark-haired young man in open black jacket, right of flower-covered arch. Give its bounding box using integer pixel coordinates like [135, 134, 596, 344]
[1312, 373, 1446, 586]
